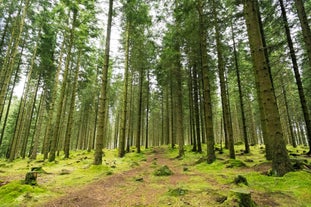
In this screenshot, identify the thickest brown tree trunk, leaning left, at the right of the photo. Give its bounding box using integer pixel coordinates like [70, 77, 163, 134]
[244, 0, 292, 176]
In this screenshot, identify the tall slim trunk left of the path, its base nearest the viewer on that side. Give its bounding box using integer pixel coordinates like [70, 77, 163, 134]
[94, 0, 113, 165]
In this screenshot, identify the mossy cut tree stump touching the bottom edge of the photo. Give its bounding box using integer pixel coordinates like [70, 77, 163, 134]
[226, 188, 257, 207]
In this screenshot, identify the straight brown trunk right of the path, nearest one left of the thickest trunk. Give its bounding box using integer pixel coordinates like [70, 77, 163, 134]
[198, 0, 216, 163]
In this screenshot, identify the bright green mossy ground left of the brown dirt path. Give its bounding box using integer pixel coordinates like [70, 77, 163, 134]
[0, 150, 149, 206]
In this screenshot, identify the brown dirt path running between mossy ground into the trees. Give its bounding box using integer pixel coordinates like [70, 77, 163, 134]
[45, 148, 190, 207]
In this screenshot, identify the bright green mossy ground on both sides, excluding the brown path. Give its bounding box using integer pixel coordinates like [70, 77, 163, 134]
[0, 145, 311, 207]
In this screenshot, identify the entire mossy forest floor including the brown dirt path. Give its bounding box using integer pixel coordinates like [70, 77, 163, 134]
[0, 146, 311, 207]
